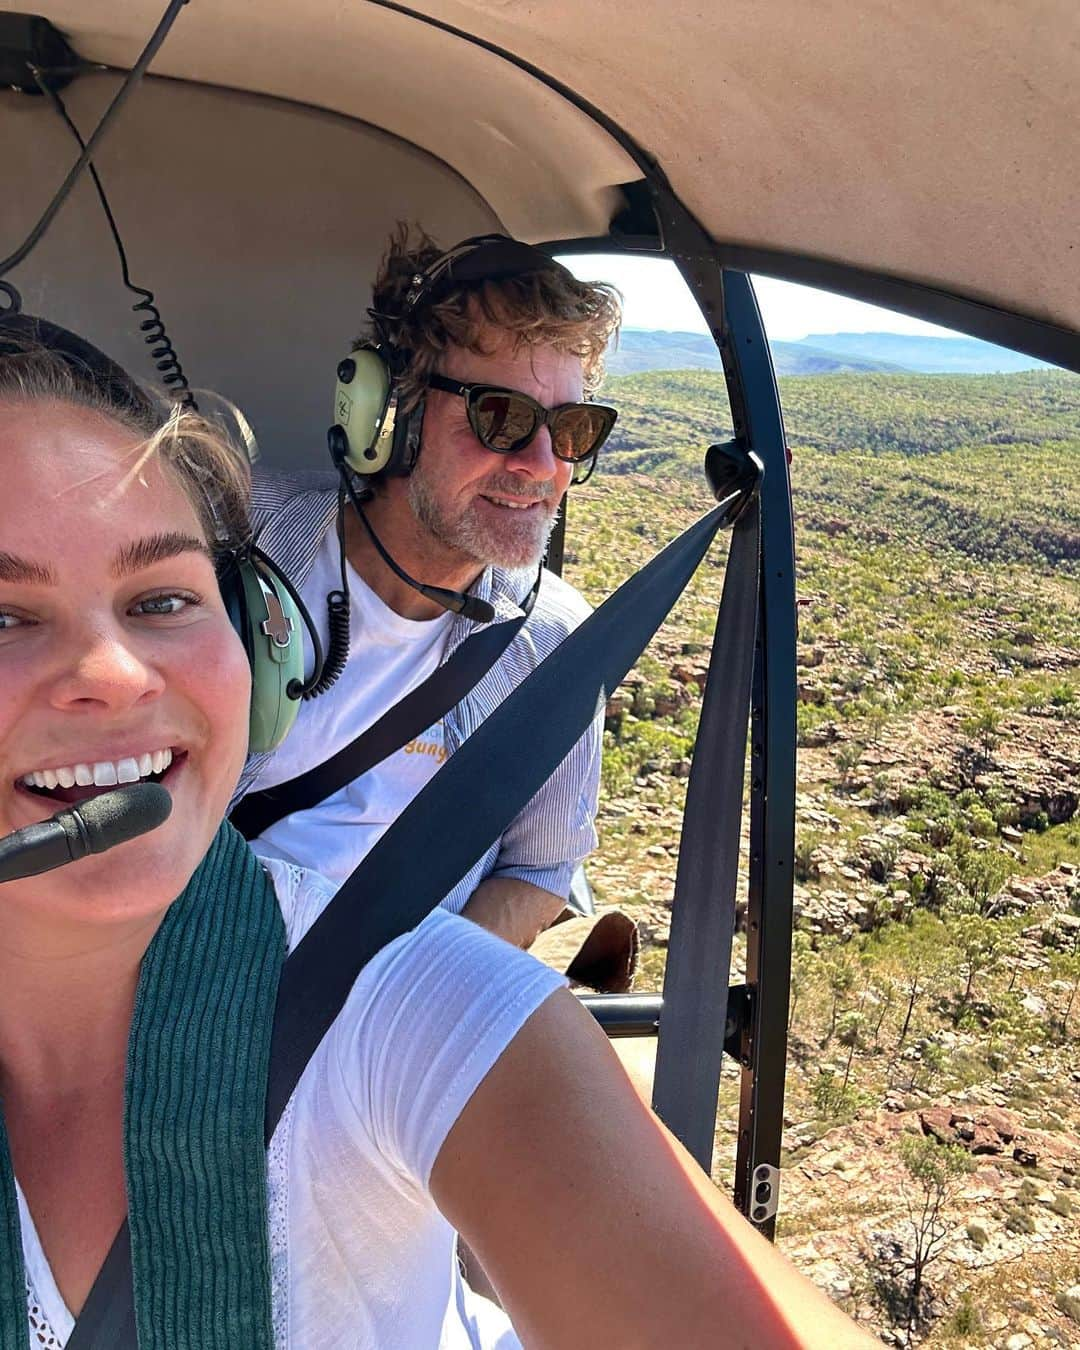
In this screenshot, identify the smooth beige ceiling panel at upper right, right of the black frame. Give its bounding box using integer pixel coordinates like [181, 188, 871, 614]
[417, 0, 1080, 329]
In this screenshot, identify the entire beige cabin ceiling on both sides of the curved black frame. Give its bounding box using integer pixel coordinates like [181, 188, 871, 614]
[7, 0, 1080, 337]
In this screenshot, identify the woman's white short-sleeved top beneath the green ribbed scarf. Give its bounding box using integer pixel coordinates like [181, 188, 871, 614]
[19, 859, 564, 1350]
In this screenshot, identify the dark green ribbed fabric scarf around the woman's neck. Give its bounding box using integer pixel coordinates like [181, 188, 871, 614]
[0, 825, 285, 1350]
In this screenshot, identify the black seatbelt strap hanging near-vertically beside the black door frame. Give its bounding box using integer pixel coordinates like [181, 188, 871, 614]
[652, 501, 760, 1172]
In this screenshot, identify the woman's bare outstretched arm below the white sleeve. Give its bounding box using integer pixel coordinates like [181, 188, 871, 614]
[431, 991, 878, 1350]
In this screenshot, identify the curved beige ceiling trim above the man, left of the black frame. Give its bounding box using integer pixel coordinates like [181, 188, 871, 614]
[0, 0, 639, 239]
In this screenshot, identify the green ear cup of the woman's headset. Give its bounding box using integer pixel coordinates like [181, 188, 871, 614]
[234, 559, 304, 753]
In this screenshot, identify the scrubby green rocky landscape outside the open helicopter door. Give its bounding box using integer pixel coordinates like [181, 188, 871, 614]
[567, 371, 1080, 1350]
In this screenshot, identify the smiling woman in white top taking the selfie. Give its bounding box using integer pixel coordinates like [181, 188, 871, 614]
[0, 318, 868, 1350]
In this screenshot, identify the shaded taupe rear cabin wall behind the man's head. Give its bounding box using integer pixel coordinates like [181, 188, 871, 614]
[0, 76, 500, 467]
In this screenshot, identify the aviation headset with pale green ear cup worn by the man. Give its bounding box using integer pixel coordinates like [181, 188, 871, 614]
[328, 234, 591, 482]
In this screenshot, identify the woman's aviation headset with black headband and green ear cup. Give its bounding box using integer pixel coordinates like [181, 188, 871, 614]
[0, 302, 307, 752]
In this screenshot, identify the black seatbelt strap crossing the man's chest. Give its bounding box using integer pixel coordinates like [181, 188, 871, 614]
[230, 614, 525, 840]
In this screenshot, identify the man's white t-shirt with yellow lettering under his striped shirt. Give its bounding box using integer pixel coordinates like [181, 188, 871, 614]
[252, 531, 454, 886]
